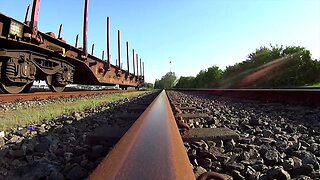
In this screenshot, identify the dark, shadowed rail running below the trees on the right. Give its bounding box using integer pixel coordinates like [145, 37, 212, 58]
[173, 89, 320, 105]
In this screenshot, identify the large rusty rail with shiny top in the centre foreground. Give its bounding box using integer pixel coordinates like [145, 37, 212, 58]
[89, 91, 195, 180]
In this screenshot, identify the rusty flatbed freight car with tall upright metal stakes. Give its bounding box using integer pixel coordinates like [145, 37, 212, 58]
[0, 0, 144, 93]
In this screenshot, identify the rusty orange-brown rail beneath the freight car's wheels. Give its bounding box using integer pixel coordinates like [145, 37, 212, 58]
[0, 90, 135, 103]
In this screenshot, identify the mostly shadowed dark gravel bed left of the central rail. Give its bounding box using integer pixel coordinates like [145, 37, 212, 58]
[0, 92, 159, 180]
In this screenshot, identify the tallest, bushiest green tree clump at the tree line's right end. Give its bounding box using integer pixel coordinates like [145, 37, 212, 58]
[221, 45, 320, 87]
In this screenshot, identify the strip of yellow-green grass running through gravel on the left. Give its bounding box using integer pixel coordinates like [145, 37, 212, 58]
[0, 91, 144, 130]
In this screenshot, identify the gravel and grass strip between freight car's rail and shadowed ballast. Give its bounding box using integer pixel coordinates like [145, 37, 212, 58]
[0, 91, 144, 131]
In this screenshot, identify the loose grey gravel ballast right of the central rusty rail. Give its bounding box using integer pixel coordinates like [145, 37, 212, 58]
[167, 91, 320, 179]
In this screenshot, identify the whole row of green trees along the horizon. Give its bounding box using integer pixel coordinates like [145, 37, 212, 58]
[155, 45, 320, 88]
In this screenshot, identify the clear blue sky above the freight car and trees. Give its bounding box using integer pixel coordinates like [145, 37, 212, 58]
[0, 0, 320, 83]
